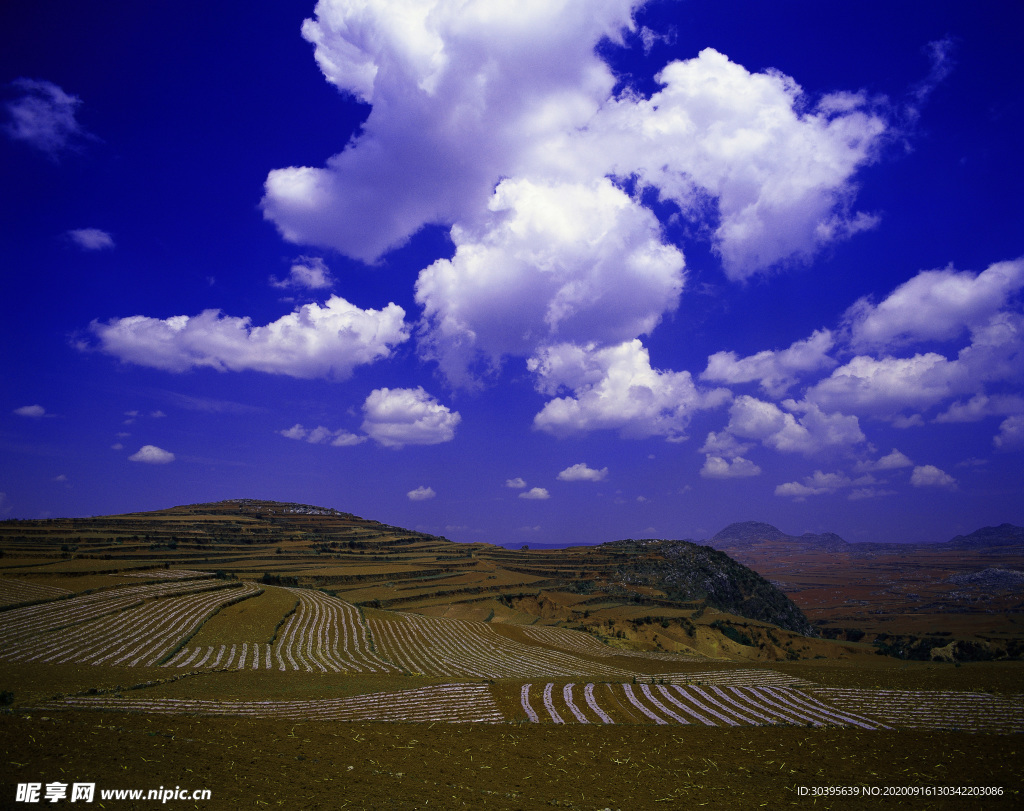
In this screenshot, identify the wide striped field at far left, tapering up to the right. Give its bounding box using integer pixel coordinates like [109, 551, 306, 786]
[0, 583, 259, 667]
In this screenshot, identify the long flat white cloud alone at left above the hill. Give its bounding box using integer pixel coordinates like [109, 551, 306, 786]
[91, 296, 409, 380]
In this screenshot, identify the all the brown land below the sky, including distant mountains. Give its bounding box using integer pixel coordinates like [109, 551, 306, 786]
[0, 500, 1024, 810]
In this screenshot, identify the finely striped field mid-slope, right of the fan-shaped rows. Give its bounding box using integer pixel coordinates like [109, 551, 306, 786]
[370, 614, 632, 679]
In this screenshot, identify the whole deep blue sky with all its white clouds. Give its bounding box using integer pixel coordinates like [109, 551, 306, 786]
[0, 0, 1024, 544]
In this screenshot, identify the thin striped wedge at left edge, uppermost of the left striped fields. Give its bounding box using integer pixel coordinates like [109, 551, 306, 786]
[0, 580, 234, 649]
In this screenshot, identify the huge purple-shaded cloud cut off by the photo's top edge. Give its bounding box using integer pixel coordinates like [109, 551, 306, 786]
[263, 0, 638, 261]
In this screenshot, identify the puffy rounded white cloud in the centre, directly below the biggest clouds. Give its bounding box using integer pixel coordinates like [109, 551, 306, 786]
[416, 177, 684, 382]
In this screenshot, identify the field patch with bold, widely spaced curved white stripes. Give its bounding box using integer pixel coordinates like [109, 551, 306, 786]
[520, 682, 886, 729]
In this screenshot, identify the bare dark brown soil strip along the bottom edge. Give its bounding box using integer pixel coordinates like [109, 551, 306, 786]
[0, 712, 1024, 811]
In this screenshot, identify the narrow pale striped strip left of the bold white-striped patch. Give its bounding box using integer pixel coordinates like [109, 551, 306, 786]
[40, 684, 504, 723]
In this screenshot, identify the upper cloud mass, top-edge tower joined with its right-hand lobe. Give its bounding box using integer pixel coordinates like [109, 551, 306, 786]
[262, 0, 888, 284]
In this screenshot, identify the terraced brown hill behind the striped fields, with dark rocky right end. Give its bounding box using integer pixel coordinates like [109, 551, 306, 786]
[0, 499, 813, 646]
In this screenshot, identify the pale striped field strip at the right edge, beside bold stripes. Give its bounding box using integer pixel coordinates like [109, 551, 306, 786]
[810, 687, 1024, 732]
